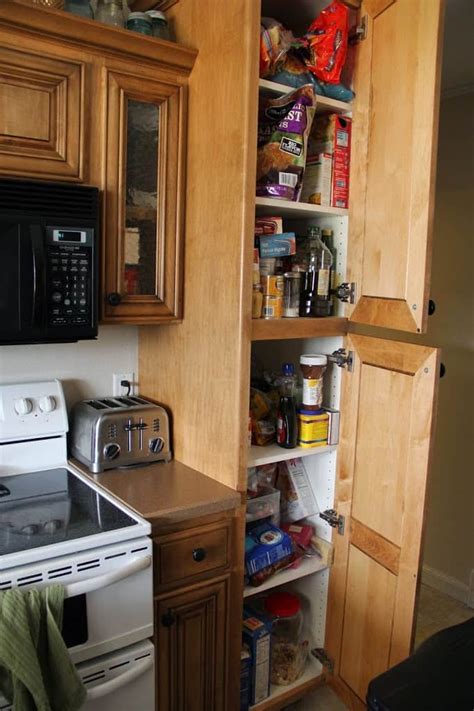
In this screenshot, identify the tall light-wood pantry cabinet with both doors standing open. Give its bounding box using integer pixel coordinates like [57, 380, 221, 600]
[140, 0, 442, 711]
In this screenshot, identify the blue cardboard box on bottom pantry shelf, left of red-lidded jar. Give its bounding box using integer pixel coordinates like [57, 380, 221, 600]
[242, 609, 271, 706]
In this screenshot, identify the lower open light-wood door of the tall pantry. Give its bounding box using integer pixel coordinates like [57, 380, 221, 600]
[325, 336, 439, 708]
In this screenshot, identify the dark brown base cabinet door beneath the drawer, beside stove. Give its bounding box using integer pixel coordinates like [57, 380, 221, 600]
[155, 577, 229, 711]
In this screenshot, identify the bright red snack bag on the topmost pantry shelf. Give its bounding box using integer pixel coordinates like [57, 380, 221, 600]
[305, 0, 349, 84]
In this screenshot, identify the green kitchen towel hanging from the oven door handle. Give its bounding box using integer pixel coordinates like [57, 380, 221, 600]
[0, 585, 86, 711]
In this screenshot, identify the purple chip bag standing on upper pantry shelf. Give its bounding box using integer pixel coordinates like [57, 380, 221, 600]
[257, 84, 316, 201]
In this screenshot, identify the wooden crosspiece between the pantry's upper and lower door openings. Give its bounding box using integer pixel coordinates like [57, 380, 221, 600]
[252, 316, 348, 341]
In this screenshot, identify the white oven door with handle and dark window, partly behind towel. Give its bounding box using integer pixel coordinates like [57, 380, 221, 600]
[0, 537, 153, 664]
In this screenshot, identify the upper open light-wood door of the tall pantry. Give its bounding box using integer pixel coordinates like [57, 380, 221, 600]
[348, 0, 444, 332]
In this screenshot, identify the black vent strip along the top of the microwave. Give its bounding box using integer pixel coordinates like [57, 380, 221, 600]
[0, 178, 99, 220]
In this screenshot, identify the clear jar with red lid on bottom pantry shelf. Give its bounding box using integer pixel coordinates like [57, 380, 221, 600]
[265, 592, 308, 686]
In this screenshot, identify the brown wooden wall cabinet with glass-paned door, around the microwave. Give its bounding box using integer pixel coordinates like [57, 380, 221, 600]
[0, 2, 197, 324]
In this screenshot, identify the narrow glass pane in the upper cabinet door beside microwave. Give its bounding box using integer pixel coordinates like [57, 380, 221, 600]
[123, 99, 160, 296]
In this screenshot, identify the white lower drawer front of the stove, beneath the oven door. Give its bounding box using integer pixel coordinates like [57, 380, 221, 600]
[0, 640, 155, 711]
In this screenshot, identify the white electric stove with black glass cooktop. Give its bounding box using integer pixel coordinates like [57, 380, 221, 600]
[0, 380, 154, 711]
